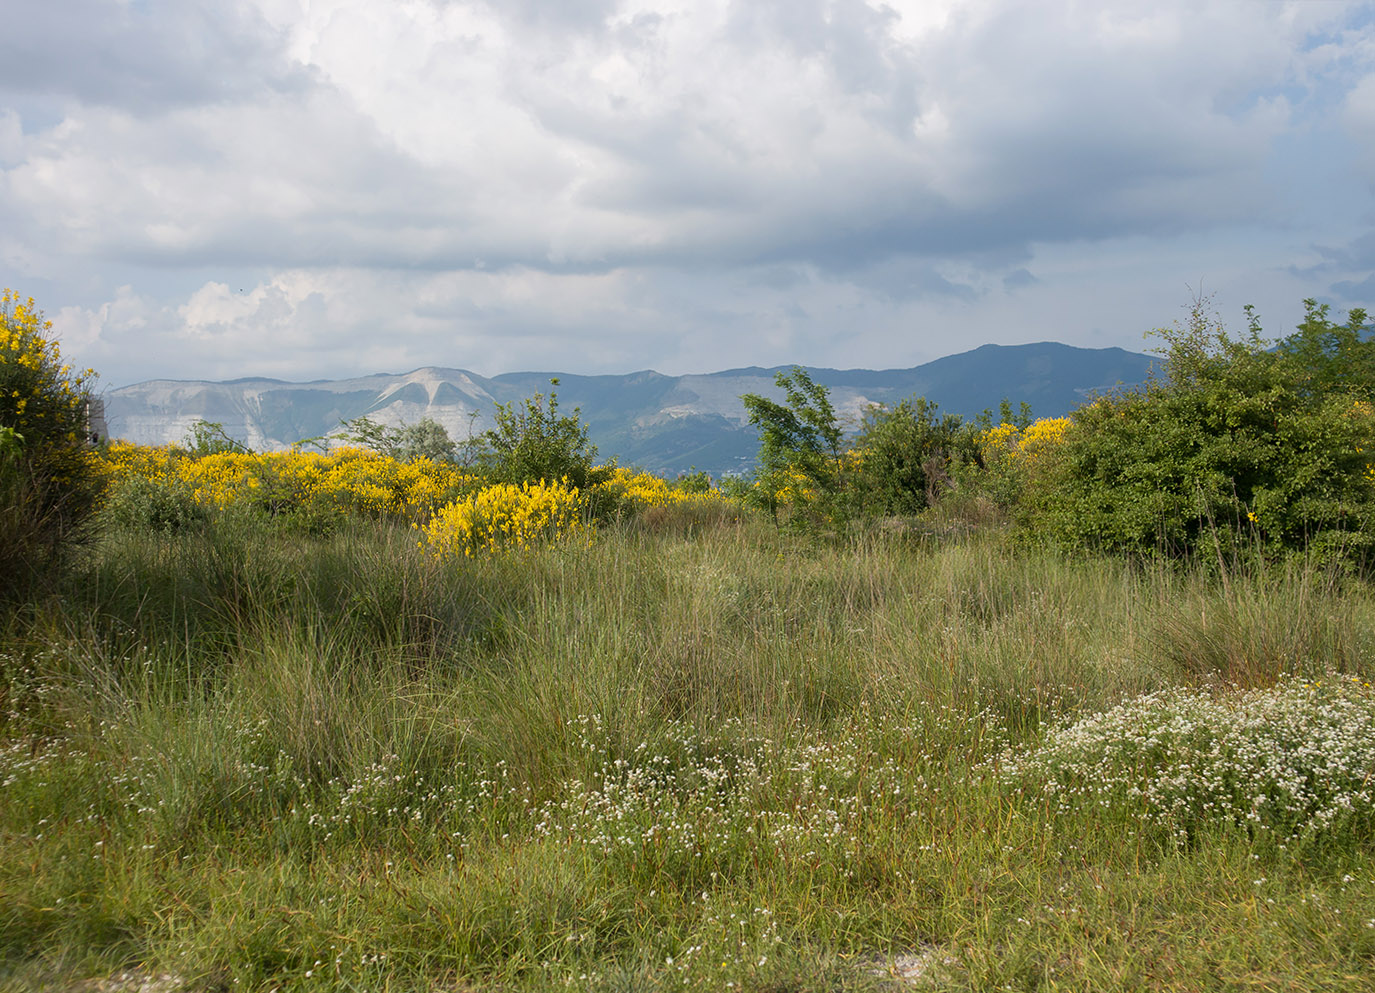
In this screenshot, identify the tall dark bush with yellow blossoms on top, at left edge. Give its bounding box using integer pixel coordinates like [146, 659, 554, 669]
[0, 290, 102, 598]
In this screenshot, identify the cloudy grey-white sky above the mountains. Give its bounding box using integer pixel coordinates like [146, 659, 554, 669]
[0, 0, 1375, 388]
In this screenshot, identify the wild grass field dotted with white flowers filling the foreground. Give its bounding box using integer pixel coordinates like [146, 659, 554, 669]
[0, 517, 1375, 993]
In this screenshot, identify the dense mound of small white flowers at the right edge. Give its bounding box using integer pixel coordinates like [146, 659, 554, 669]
[998, 677, 1375, 844]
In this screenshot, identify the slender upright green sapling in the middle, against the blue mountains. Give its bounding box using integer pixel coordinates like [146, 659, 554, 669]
[740, 366, 843, 520]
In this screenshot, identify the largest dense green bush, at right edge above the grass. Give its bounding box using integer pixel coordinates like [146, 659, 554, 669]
[1024, 300, 1375, 558]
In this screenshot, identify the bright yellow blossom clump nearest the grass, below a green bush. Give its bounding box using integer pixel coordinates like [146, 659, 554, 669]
[422, 480, 593, 558]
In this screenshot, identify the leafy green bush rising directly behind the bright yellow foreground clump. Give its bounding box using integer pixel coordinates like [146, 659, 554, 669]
[481, 380, 615, 490]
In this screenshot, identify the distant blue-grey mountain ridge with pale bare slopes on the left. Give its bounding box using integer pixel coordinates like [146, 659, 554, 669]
[105, 341, 1154, 474]
